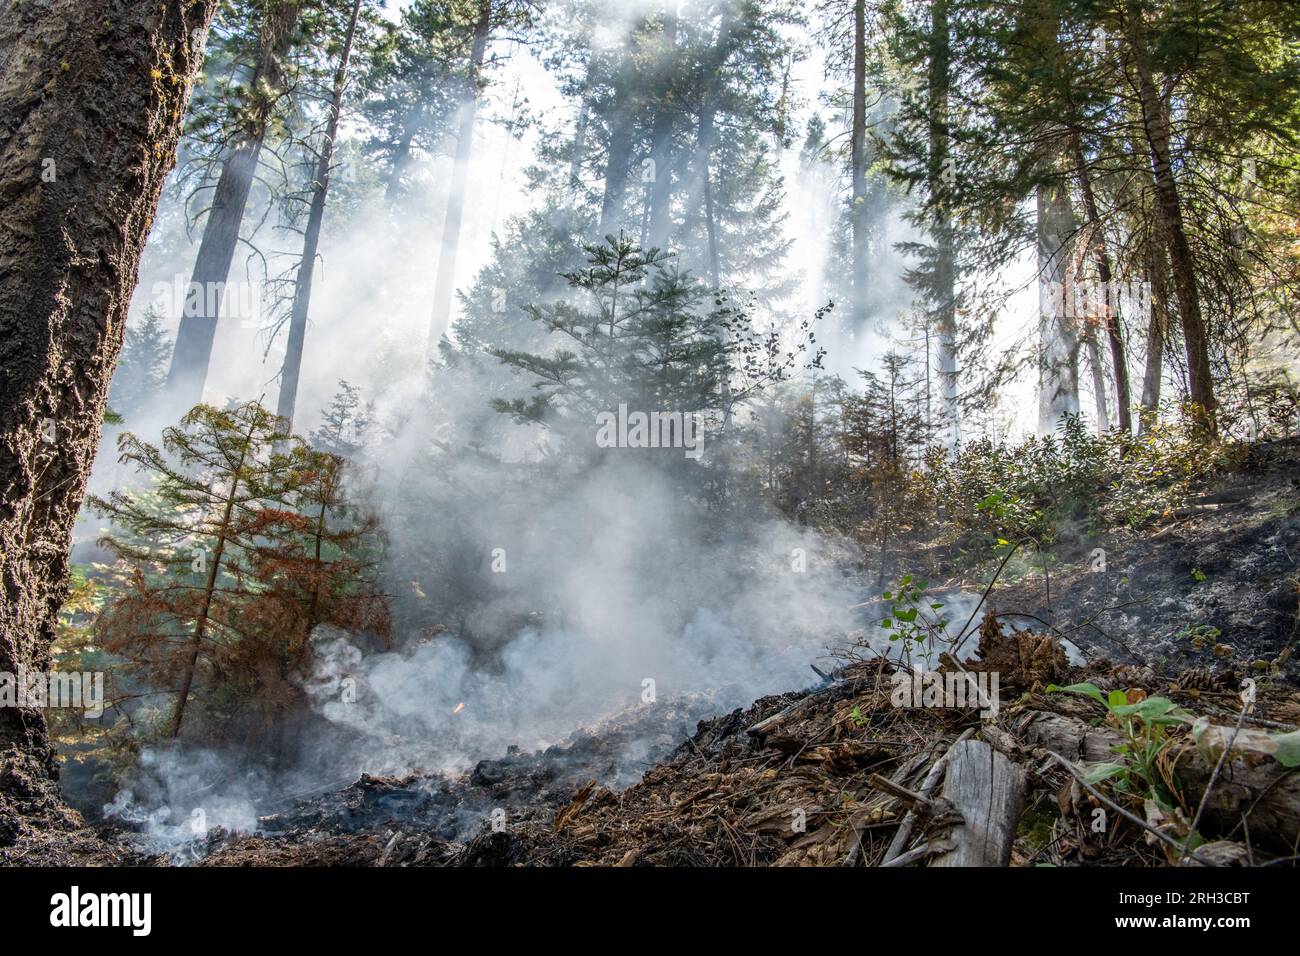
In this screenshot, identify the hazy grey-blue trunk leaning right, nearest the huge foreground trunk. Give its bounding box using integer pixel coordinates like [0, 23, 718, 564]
[164, 0, 299, 414]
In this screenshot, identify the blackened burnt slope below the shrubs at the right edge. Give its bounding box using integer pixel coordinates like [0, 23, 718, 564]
[993, 441, 1300, 678]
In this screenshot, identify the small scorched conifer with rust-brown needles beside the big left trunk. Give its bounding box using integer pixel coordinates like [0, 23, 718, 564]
[90, 403, 384, 737]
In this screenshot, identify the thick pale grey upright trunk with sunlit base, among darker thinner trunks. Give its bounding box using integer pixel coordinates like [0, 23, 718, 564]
[1036, 167, 1079, 432]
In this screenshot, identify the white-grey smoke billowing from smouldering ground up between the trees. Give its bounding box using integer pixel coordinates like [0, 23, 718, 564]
[79, 5, 998, 848]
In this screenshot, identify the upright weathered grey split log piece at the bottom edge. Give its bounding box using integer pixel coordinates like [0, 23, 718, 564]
[930, 740, 1024, 866]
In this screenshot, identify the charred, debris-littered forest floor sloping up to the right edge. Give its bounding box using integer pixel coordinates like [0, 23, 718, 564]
[14, 442, 1300, 866]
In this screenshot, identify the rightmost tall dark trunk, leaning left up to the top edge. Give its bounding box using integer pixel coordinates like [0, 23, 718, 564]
[1125, 0, 1217, 434]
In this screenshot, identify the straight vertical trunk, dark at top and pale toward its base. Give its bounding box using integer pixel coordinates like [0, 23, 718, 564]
[928, 0, 961, 447]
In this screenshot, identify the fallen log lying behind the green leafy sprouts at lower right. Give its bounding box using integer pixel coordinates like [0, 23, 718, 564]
[1017, 711, 1300, 852]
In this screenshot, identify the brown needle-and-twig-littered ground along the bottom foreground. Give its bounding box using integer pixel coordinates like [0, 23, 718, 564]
[189, 639, 1300, 866]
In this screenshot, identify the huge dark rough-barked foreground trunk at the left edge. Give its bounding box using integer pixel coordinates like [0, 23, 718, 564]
[0, 0, 217, 845]
